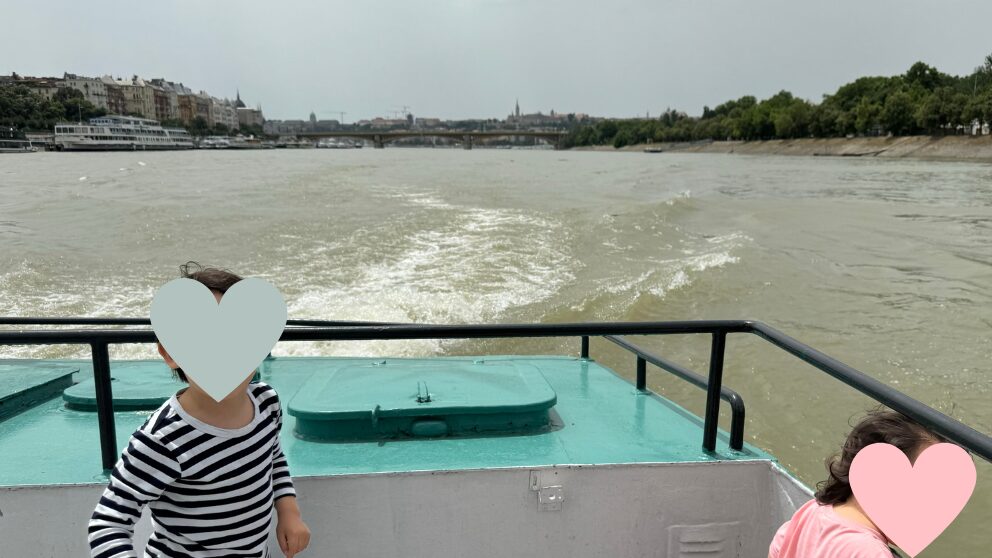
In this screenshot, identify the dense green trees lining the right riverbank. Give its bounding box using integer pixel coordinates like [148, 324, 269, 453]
[565, 54, 992, 148]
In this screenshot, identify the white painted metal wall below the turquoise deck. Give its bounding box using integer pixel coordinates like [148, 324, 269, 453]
[0, 461, 811, 558]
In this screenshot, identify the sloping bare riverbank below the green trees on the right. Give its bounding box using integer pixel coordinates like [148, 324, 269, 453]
[576, 136, 992, 162]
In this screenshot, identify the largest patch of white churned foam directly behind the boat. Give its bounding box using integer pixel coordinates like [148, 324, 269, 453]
[273, 200, 574, 356]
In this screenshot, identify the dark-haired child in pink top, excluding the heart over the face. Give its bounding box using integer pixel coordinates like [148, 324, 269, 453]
[768, 410, 946, 558]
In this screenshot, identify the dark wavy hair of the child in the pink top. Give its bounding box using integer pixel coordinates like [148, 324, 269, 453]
[816, 407, 947, 505]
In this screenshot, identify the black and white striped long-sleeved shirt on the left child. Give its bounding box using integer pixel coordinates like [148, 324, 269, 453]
[89, 382, 296, 558]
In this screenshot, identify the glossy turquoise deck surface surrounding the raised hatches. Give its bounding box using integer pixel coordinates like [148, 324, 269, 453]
[0, 357, 773, 486]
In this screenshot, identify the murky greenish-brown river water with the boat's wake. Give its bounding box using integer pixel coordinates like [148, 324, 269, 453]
[0, 149, 992, 557]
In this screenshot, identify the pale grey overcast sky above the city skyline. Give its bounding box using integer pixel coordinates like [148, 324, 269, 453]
[0, 0, 992, 122]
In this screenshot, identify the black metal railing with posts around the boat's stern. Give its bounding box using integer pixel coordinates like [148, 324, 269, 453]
[0, 318, 992, 469]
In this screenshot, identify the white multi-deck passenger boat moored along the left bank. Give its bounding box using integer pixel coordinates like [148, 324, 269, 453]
[54, 116, 193, 151]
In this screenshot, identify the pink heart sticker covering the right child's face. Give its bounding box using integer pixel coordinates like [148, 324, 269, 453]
[848, 444, 977, 556]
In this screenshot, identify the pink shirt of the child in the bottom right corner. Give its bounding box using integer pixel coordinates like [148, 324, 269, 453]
[768, 500, 892, 558]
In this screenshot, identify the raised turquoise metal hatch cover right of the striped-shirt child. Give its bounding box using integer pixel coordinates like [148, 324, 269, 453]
[287, 360, 557, 441]
